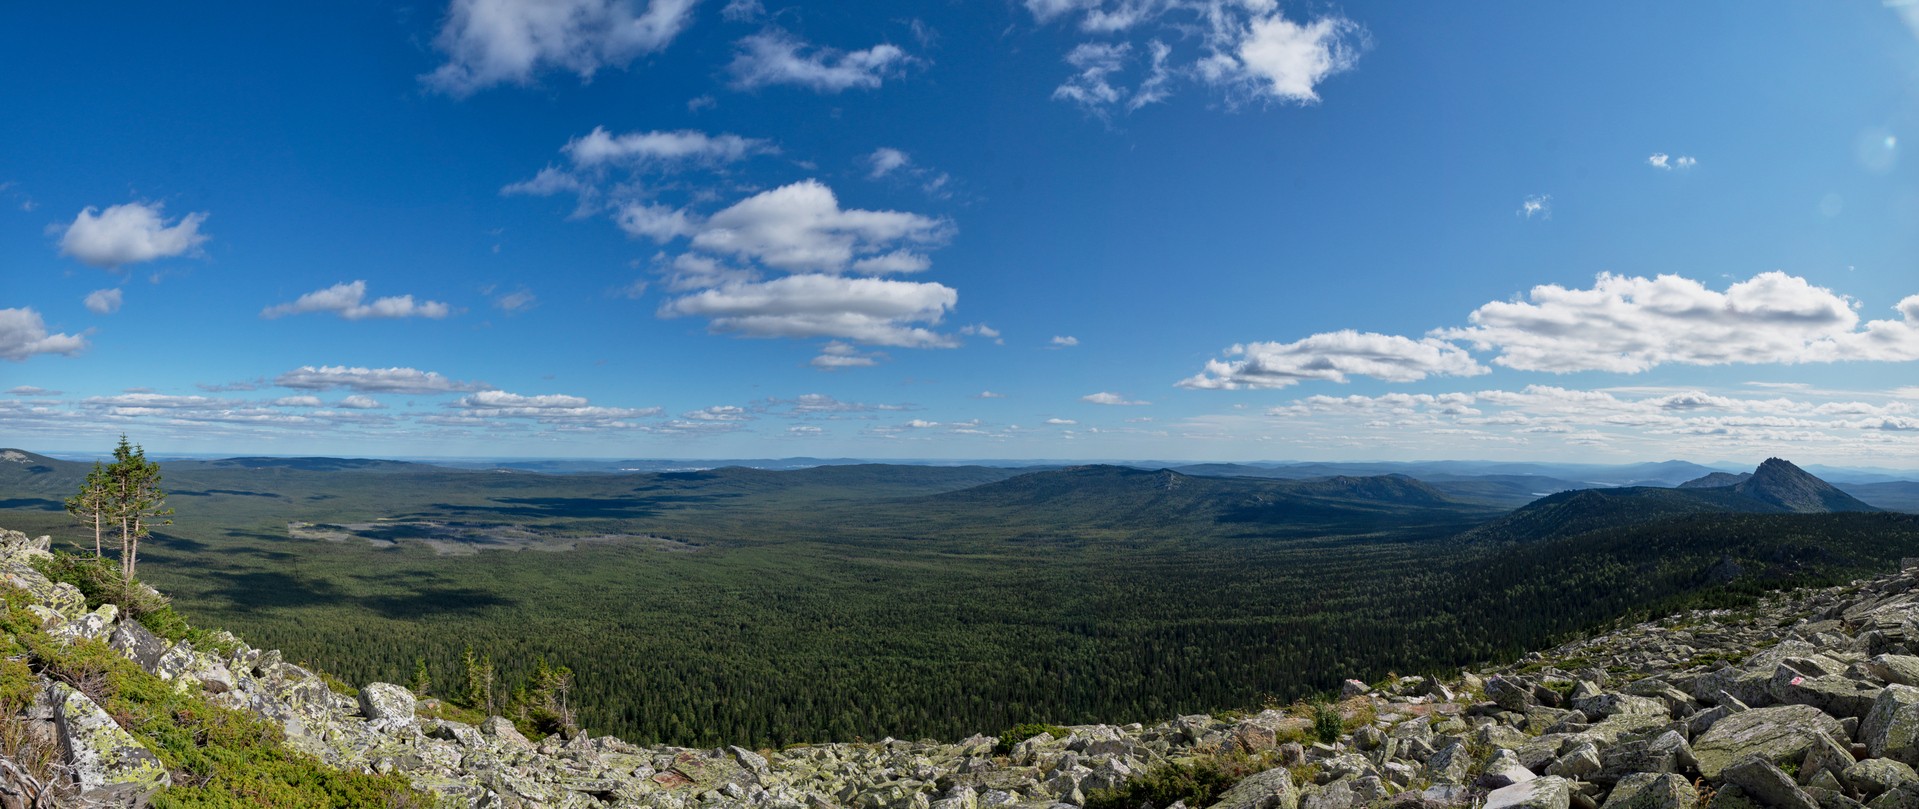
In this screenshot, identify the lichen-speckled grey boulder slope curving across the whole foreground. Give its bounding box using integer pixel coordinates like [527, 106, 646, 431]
[0, 531, 1919, 809]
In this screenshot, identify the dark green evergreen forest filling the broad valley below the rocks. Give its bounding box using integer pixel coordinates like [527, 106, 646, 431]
[0, 448, 1919, 746]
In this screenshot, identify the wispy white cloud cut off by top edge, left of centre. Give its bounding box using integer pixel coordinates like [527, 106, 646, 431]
[422, 0, 699, 96]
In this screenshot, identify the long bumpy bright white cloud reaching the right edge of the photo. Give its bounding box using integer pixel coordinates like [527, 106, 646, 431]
[1433, 270, 1919, 374]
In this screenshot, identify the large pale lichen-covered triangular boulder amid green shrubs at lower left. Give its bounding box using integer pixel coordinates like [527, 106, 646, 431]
[50, 682, 173, 805]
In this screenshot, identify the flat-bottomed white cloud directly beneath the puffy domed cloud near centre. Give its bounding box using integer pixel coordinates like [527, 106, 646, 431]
[660, 274, 960, 347]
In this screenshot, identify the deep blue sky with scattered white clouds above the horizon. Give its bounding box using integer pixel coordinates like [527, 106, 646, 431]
[0, 0, 1919, 468]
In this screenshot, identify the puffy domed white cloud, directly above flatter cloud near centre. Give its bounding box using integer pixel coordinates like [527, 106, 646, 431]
[693, 180, 952, 270]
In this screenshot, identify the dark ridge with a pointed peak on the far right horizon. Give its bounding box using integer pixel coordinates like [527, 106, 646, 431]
[1462, 458, 1879, 543]
